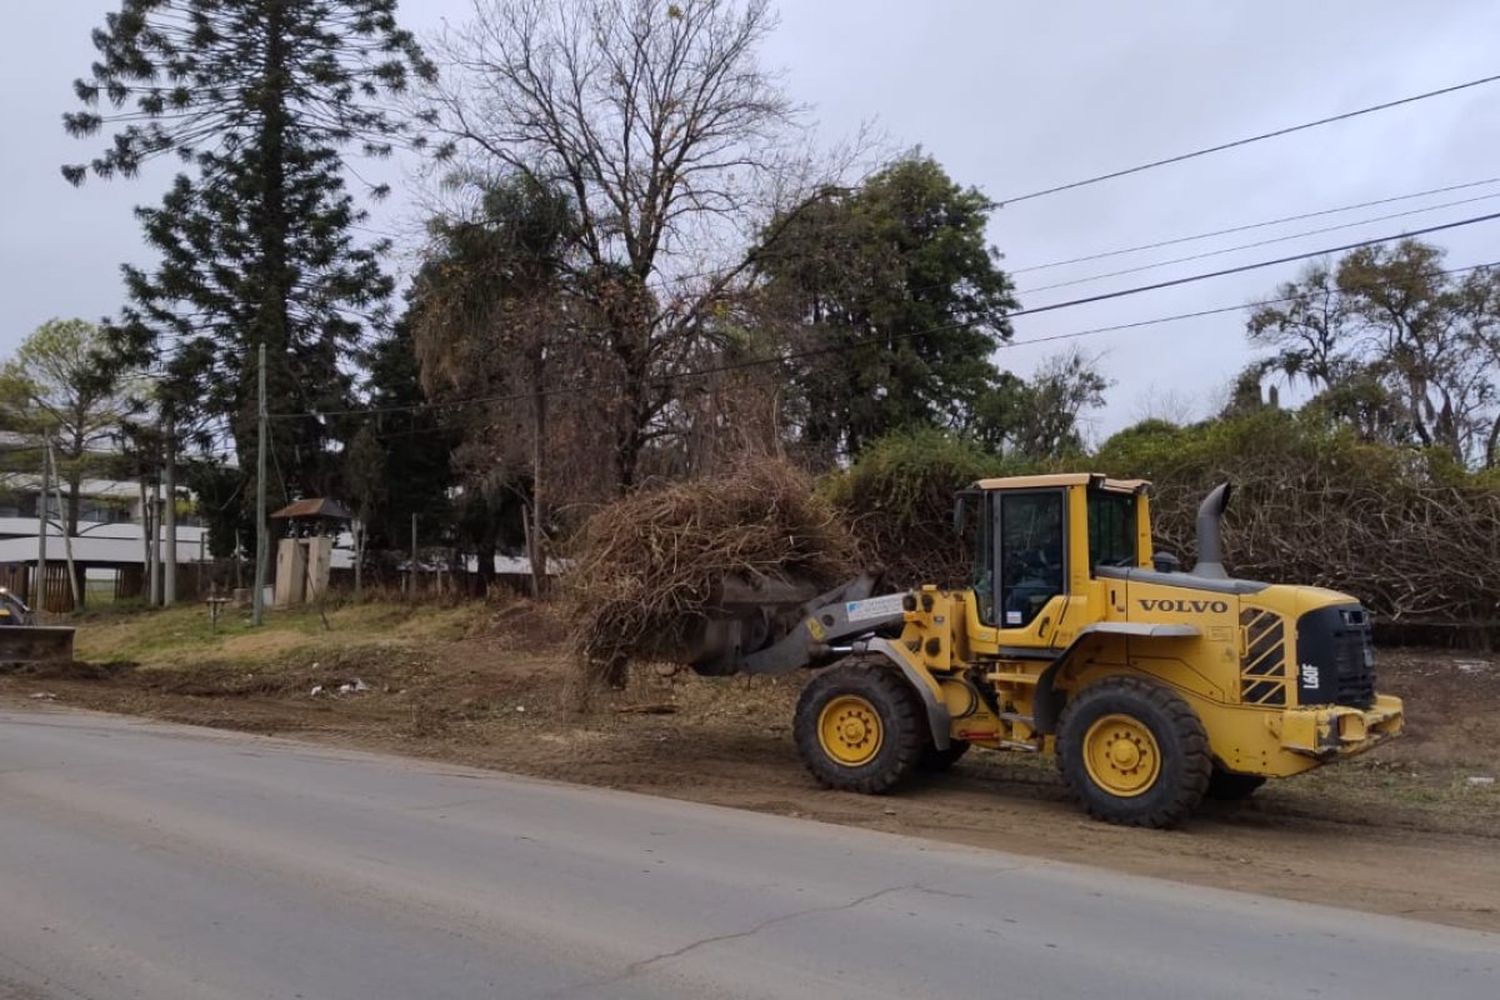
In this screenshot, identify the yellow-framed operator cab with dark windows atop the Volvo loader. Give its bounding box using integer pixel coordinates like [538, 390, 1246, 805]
[956, 474, 1152, 646]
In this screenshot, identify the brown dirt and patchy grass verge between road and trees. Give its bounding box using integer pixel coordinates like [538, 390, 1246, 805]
[0, 603, 1500, 931]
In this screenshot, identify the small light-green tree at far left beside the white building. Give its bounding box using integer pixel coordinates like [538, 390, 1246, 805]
[0, 319, 140, 535]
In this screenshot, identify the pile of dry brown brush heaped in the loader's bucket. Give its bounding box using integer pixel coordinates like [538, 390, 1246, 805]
[563, 460, 858, 685]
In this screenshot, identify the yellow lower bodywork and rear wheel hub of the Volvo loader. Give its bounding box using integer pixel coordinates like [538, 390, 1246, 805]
[902, 569, 1403, 779]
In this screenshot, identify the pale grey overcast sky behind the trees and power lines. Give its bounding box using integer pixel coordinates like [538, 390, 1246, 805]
[0, 0, 1500, 436]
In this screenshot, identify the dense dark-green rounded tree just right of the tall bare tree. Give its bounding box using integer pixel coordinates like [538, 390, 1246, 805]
[758, 154, 1017, 462]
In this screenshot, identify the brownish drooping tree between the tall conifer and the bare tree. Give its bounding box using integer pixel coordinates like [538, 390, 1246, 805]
[408, 174, 579, 594]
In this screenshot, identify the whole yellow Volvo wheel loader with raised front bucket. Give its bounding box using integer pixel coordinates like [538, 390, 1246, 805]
[684, 474, 1403, 828]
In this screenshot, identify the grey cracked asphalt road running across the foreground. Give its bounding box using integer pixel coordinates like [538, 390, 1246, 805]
[0, 711, 1500, 1000]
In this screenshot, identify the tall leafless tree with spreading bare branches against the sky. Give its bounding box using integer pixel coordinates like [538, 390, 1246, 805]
[426, 0, 798, 489]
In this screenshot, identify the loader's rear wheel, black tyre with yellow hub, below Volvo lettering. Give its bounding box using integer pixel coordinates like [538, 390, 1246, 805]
[1056, 678, 1214, 829]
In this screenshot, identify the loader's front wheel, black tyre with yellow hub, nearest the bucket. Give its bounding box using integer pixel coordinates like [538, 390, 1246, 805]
[792, 663, 932, 795]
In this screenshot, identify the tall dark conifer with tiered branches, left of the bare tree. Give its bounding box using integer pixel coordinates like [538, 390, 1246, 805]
[63, 0, 434, 493]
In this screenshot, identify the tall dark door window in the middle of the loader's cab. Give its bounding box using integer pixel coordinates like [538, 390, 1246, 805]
[998, 490, 1065, 628]
